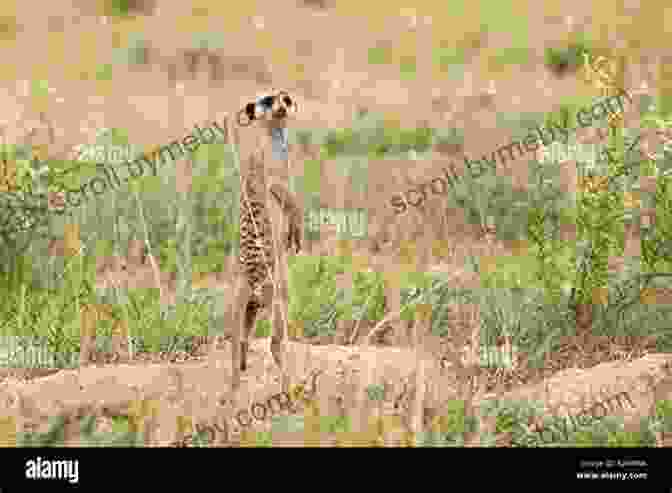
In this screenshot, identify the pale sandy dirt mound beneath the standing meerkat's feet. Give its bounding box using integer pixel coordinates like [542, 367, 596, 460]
[0, 341, 446, 445]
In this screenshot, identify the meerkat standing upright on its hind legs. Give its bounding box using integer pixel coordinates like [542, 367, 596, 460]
[223, 87, 303, 390]
